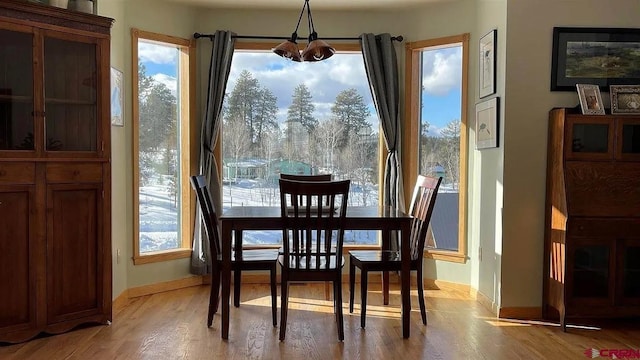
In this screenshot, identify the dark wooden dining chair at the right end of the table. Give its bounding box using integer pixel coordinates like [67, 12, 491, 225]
[349, 175, 442, 328]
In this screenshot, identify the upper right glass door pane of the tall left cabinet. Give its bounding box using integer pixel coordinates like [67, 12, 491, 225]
[44, 35, 98, 156]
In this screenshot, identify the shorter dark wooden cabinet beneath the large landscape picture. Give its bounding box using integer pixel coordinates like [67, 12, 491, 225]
[543, 109, 640, 329]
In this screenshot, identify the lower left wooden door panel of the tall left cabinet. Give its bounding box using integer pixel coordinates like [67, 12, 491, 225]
[0, 185, 37, 337]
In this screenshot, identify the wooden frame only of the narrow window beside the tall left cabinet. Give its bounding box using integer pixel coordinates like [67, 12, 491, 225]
[131, 28, 198, 265]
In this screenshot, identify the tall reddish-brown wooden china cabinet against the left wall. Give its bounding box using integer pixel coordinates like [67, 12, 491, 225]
[0, 0, 112, 342]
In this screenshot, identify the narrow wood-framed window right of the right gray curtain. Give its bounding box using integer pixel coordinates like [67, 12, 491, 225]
[403, 34, 469, 262]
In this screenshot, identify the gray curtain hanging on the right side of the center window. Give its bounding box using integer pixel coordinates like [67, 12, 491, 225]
[360, 34, 405, 249]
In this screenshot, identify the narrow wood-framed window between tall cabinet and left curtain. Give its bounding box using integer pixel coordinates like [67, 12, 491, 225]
[131, 29, 195, 264]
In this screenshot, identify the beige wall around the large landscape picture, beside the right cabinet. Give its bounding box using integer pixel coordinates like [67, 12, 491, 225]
[502, 0, 640, 307]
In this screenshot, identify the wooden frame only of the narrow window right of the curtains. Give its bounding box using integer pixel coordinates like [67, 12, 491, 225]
[402, 33, 470, 263]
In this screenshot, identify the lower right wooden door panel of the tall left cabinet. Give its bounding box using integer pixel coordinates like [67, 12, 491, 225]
[47, 184, 103, 324]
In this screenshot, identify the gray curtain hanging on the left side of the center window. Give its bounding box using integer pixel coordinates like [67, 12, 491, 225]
[191, 30, 235, 275]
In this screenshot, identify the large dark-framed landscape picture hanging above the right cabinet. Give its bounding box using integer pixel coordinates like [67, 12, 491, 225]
[551, 27, 640, 91]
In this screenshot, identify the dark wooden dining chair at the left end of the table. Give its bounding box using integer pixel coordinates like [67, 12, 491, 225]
[190, 175, 278, 326]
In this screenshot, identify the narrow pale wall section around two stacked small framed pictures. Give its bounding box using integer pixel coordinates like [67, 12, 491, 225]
[468, 0, 508, 309]
